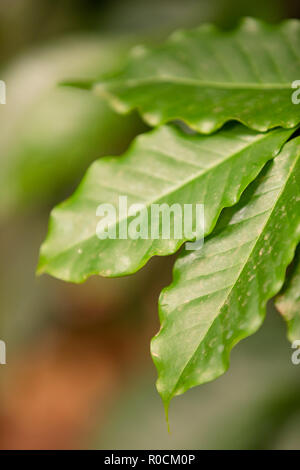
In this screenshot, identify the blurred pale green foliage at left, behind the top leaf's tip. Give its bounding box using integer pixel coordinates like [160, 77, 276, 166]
[0, 35, 142, 214]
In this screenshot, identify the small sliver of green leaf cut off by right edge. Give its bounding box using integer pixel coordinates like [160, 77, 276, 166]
[275, 249, 300, 343]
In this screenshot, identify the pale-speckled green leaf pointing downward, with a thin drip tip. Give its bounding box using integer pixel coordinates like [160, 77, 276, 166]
[151, 138, 300, 407]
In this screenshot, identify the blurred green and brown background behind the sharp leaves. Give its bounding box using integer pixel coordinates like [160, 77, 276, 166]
[0, 0, 300, 449]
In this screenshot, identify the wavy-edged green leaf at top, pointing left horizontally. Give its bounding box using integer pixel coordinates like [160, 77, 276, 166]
[94, 18, 300, 134]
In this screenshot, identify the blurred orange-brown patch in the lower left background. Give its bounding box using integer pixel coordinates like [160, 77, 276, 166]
[0, 290, 154, 449]
